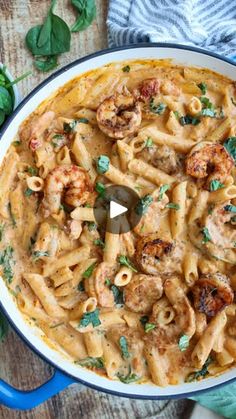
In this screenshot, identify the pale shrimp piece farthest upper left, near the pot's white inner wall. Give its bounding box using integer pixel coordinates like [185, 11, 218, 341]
[20, 111, 55, 151]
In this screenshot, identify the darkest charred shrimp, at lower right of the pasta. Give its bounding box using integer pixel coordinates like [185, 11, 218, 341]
[192, 272, 234, 317]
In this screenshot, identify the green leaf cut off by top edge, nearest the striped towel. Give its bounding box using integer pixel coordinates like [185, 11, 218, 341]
[71, 0, 96, 32]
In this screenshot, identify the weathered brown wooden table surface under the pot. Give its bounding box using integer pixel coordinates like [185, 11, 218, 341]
[0, 0, 195, 419]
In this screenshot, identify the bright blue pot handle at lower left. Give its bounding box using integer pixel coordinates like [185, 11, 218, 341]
[0, 370, 76, 410]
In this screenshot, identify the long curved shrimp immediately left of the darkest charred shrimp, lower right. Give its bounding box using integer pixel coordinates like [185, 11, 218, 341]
[164, 276, 196, 337]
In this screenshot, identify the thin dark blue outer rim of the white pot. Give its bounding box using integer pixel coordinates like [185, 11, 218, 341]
[0, 42, 236, 400]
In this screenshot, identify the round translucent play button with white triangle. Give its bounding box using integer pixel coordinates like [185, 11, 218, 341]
[94, 185, 142, 234]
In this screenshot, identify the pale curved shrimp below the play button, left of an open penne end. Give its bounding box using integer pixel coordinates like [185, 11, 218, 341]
[93, 262, 116, 307]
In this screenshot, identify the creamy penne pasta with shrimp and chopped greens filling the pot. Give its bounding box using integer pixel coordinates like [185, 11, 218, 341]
[0, 60, 236, 386]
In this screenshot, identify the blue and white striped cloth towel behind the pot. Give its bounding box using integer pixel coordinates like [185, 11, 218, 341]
[107, 0, 236, 57]
